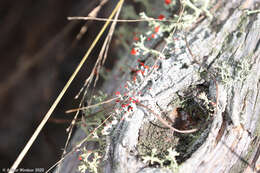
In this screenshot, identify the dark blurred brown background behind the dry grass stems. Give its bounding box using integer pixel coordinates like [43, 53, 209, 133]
[0, 0, 120, 170]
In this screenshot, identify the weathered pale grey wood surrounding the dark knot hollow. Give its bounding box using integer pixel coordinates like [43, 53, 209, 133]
[103, 1, 260, 173]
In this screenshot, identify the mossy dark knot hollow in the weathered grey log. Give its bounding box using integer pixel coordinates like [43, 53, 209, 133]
[137, 85, 214, 166]
